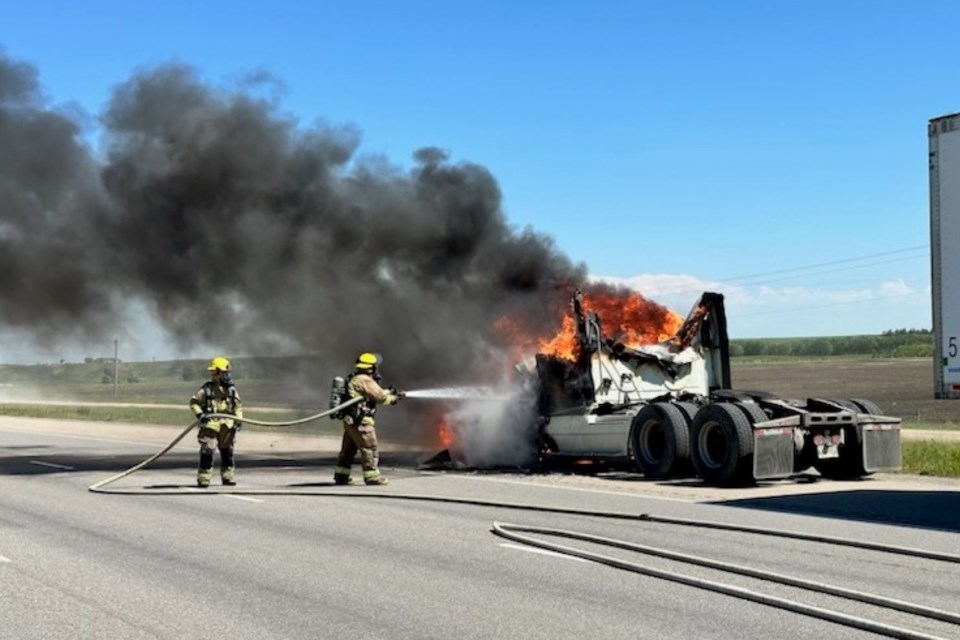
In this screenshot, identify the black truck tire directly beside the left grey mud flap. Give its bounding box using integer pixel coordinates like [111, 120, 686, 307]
[691, 402, 753, 485]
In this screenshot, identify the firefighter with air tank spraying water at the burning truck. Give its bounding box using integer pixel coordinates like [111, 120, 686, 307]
[333, 353, 404, 485]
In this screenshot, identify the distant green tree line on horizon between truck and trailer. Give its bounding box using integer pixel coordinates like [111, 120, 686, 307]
[730, 329, 933, 358]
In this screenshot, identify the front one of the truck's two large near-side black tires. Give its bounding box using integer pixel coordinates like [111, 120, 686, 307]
[630, 402, 690, 478]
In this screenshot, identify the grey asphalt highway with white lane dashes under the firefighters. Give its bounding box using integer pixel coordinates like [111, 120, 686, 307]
[0, 418, 960, 640]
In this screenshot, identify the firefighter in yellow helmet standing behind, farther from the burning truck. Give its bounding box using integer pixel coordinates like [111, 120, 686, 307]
[190, 356, 243, 487]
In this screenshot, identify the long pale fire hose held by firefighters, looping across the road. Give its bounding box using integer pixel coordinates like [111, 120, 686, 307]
[88, 398, 960, 640]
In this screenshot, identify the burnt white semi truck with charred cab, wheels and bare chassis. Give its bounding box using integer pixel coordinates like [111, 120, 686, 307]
[536, 292, 901, 484]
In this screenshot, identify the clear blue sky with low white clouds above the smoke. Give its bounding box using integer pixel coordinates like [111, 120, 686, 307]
[0, 0, 948, 360]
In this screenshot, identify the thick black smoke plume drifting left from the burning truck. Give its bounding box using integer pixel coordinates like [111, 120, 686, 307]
[0, 56, 586, 386]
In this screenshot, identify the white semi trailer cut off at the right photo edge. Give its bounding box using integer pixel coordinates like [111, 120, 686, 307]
[927, 113, 960, 398]
